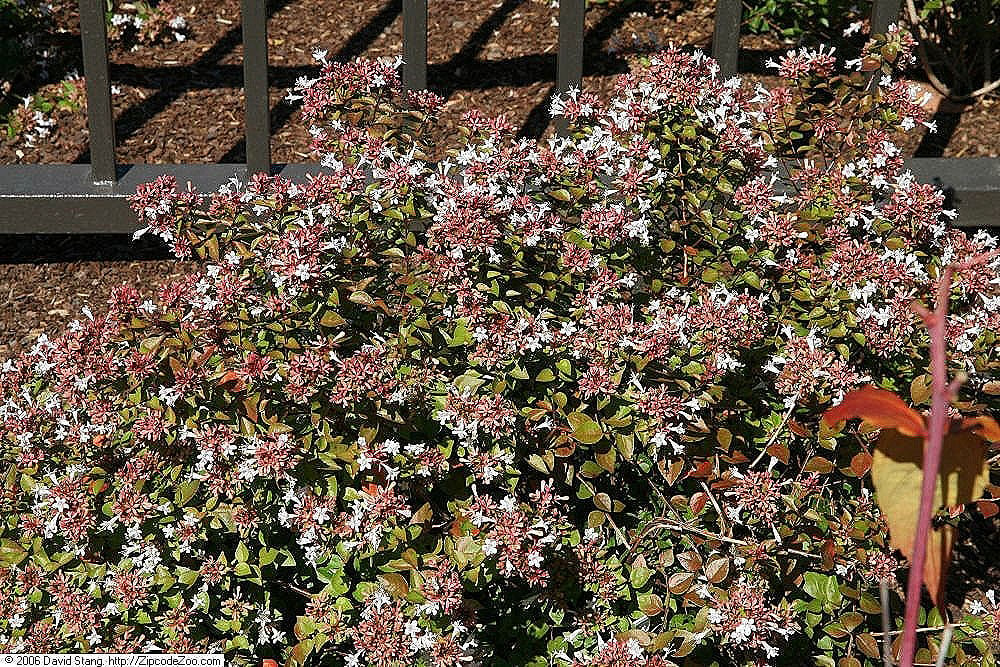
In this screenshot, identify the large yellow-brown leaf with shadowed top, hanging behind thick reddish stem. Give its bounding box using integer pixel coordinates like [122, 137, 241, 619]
[871, 429, 989, 607]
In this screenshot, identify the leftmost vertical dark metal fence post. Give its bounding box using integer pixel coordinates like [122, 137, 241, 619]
[80, 0, 116, 185]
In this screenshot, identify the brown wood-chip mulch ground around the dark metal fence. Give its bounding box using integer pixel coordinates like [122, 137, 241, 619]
[0, 0, 1000, 358]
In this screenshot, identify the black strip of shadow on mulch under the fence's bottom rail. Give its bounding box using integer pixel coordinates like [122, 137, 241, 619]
[0, 234, 176, 264]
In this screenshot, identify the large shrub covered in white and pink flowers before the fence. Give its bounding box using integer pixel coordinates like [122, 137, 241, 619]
[0, 27, 1000, 667]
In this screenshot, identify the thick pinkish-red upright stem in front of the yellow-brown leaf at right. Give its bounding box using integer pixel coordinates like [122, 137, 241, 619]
[900, 267, 952, 667]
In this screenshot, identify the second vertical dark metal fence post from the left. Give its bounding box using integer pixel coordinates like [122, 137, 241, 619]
[240, 0, 271, 178]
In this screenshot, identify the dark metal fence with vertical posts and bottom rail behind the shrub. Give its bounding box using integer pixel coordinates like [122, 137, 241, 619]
[0, 0, 1000, 234]
